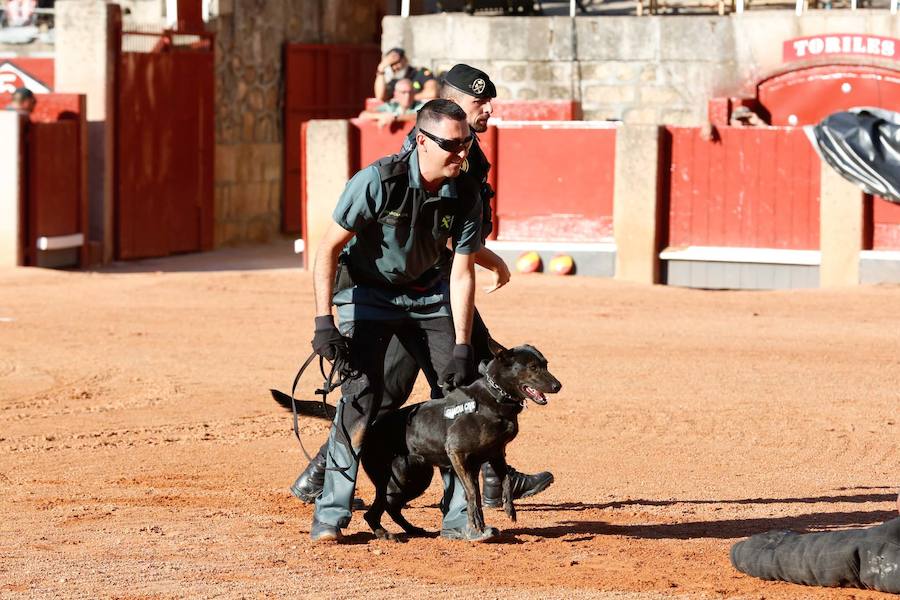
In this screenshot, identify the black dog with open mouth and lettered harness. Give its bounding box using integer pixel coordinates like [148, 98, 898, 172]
[272, 340, 562, 539]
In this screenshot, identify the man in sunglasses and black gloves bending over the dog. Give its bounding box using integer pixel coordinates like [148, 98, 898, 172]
[310, 99, 497, 541]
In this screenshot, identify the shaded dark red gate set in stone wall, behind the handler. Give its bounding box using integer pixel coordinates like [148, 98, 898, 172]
[281, 44, 381, 233]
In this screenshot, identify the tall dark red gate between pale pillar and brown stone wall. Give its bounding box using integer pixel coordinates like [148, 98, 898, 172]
[114, 26, 215, 259]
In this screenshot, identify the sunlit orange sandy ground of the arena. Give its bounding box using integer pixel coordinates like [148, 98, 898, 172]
[0, 244, 900, 599]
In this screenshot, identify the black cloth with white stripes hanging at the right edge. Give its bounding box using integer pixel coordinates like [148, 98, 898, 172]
[804, 108, 900, 203]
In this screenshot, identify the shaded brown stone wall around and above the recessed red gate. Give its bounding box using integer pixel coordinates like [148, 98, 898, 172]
[211, 0, 380, 245]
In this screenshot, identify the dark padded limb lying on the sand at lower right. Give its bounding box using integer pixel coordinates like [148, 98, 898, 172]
[731, 518, 900, 594]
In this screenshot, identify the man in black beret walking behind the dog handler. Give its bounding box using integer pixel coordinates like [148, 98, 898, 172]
[291, 64, 553, 506]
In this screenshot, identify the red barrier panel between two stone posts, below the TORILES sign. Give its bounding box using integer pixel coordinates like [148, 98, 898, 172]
[667, 127, 820, 250]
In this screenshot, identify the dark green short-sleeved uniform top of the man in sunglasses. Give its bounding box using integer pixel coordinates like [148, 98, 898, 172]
[333, 150, 482, 324]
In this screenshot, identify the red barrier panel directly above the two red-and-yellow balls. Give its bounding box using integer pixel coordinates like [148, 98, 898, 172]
[494, 122, 616, 242]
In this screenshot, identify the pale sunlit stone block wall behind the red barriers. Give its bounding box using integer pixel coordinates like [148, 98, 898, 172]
[382, 10, 900, 125]
